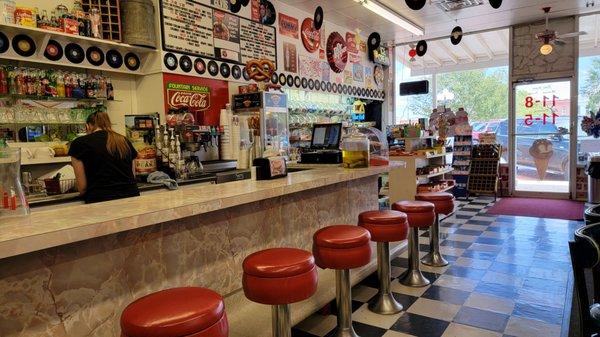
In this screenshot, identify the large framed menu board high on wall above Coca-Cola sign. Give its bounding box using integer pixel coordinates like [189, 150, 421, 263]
[160, 0, 277, 64]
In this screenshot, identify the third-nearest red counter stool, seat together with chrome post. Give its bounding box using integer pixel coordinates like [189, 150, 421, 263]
[313, 225, 371, 337]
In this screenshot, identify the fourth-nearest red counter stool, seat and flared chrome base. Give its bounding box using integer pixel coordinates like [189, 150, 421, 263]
[358, 211, 408, 315]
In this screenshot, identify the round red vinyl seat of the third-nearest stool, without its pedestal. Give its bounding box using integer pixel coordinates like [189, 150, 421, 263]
[313, 225, 371, 270]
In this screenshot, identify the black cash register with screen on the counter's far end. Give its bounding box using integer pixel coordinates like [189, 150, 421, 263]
[300, 123, 342, 164]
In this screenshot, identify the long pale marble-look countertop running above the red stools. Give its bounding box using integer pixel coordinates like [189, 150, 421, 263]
[0, 163, 396, 259]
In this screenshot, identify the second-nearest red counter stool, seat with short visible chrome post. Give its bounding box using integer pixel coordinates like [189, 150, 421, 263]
[242, 248, 318, 337]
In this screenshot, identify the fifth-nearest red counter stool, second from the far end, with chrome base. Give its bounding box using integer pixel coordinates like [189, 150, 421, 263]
[392, 201, 435, 287]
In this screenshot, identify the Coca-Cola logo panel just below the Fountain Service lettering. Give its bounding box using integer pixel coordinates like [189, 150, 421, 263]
[166, 82, 210, 112]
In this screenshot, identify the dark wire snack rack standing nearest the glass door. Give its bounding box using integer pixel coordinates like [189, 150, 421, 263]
[468, 144, 502, 199]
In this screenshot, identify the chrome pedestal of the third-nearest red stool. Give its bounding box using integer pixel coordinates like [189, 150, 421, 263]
[333, 269, 360, 337]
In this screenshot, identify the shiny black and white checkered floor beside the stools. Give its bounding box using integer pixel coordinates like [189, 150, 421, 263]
[292, 198, 583, 337]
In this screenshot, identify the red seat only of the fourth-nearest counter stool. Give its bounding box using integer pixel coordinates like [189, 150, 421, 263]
[358, 210, 408, 242]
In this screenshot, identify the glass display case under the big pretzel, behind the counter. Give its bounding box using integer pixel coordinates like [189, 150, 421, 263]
[233, 91, 290, 158]
